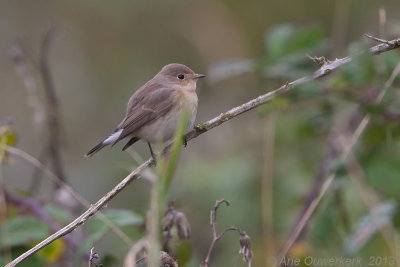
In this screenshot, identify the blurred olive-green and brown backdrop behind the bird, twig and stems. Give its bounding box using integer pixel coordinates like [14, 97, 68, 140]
[0, 0, 400, 266]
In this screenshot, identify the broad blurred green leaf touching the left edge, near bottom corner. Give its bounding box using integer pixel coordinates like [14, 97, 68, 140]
[0, 216, 50, 249]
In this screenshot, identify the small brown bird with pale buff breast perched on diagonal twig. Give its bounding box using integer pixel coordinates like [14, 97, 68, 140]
[85, 63, 205, 159]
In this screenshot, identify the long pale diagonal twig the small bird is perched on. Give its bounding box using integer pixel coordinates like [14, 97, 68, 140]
[6, 34, 400, 267]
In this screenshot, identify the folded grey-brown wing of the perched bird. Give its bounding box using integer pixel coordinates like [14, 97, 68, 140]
[114, 85, 174, 144]
